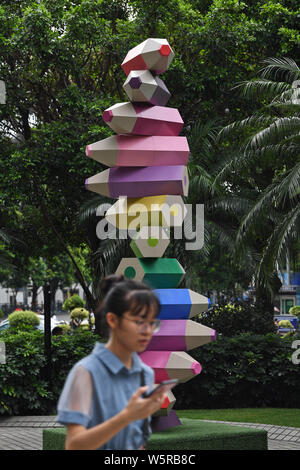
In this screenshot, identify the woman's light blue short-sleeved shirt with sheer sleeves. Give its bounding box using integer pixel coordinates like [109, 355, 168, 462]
[57, 343, 154, 450]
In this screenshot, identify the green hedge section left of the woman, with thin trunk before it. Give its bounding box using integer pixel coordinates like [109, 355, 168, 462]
[0, 330, 97, 415]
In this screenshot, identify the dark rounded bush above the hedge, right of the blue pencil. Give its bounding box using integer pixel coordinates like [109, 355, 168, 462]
[197, 301, 275, 337]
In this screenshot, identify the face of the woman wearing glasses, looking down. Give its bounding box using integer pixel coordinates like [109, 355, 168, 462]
[108, 307, 159, 353]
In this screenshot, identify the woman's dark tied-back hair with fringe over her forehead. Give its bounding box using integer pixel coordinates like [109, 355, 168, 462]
[94, 274, 160, 336]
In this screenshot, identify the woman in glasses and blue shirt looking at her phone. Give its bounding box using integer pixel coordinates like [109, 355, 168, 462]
[57, 276, 165, 450]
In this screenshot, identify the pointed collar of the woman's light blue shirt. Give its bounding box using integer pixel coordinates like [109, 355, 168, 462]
[93, 343, 142, 374]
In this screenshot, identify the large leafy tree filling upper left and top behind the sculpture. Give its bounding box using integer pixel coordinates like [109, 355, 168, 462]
[0, 0, 297, 308]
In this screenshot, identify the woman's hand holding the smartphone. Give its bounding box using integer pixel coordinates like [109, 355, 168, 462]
[124, 385, 166, 421]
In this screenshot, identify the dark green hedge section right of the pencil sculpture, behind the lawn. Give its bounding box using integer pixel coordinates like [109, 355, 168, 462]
[175, 333, 300, 409]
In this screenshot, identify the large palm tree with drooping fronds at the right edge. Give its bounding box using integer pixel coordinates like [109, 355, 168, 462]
[215, 58, 300, 295]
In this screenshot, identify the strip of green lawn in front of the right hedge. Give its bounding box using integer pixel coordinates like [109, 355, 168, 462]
[175, 408, 300, 428]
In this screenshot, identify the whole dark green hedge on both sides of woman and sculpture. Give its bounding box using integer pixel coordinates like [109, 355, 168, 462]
[0, 329, 300, 415]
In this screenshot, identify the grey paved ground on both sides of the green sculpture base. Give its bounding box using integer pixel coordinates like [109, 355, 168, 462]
[0, 416, 300, 450]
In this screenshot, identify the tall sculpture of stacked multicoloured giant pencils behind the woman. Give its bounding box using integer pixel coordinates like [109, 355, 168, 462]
[86, 38, 215, 430]
